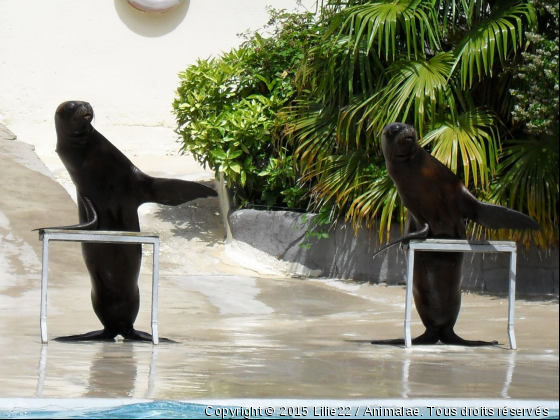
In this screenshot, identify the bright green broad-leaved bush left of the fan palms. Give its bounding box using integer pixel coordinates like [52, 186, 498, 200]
[173, 10, 313, 207]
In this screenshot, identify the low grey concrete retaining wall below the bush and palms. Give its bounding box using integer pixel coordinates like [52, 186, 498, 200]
[229, 210, 558, 295]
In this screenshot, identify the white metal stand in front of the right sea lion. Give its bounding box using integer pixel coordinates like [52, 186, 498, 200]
[404, 239, 517, 350]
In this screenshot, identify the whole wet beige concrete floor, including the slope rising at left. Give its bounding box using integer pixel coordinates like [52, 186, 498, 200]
[0, 135, 559, 400]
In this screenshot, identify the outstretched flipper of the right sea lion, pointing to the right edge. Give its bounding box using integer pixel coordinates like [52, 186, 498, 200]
[462, 187, 539, 230]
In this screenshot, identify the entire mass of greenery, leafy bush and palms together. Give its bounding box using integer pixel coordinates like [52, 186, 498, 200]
[174, 0, 558, 247]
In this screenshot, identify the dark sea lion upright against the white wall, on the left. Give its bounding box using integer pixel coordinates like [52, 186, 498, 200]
[38, 101, 217, 341]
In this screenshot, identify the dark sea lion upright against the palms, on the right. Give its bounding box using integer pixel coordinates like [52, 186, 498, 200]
[372, 123, 539, 346]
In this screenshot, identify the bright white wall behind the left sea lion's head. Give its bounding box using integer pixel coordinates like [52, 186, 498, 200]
[0, 0, 315, 155]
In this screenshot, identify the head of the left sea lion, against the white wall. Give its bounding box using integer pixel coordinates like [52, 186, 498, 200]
[54, 101, 93, 137]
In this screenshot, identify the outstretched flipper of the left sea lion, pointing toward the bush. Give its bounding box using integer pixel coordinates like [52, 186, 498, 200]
[138, 174, 218, 206]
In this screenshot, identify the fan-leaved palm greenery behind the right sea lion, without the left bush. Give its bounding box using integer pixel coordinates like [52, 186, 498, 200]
[283, 0, 558, 246]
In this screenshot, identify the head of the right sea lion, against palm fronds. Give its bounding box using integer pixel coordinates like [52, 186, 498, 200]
[381, 123, 418, 161]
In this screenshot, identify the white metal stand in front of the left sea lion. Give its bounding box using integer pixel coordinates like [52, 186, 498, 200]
[39, 229, 159, 344]
